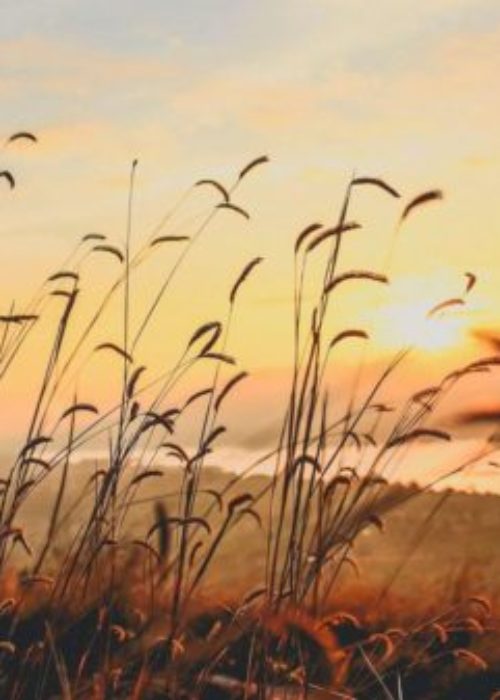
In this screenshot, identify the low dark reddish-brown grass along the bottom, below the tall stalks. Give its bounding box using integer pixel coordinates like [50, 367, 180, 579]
[1, 562, 500, 699]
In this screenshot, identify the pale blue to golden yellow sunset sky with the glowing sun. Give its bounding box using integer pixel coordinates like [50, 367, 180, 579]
[0, 0, 500, 492]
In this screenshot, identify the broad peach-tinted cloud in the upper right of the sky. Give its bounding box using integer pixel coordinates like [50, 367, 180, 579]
[163, 16, 500, 155]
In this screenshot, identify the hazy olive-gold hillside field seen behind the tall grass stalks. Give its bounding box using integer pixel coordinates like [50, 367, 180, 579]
[21, 462, 500, 603]
